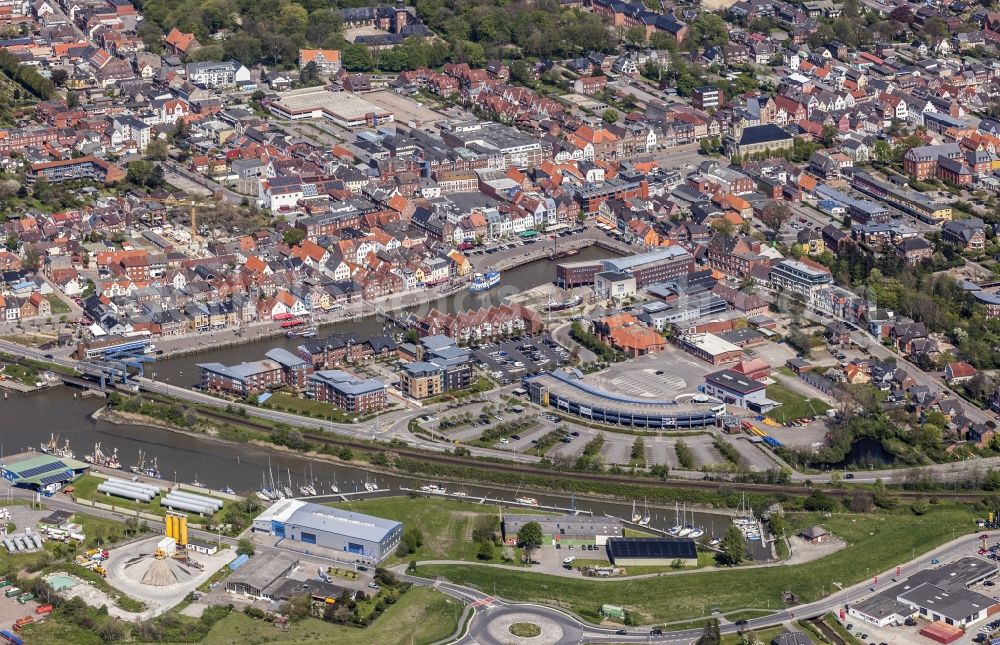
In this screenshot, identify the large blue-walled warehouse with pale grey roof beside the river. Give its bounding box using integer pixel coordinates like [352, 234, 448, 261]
[253, 499, 403, 562]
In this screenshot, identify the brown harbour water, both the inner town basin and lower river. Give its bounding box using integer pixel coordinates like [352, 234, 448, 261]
[0, 247, 764, 557]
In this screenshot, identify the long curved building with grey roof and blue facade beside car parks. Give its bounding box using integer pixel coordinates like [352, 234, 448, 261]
[524, 372, 726, 429]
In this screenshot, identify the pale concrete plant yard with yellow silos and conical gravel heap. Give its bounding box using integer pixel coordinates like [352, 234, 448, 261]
[102, 512, 236, 616]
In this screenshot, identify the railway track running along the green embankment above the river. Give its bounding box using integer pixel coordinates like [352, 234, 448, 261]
[135, 392, 983, 502]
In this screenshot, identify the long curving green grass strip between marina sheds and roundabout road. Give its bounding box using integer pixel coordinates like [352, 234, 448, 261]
[418, 505, 975, 623]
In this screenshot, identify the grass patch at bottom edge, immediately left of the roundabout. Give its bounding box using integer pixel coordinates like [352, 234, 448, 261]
[203, 587, 462, 645]
